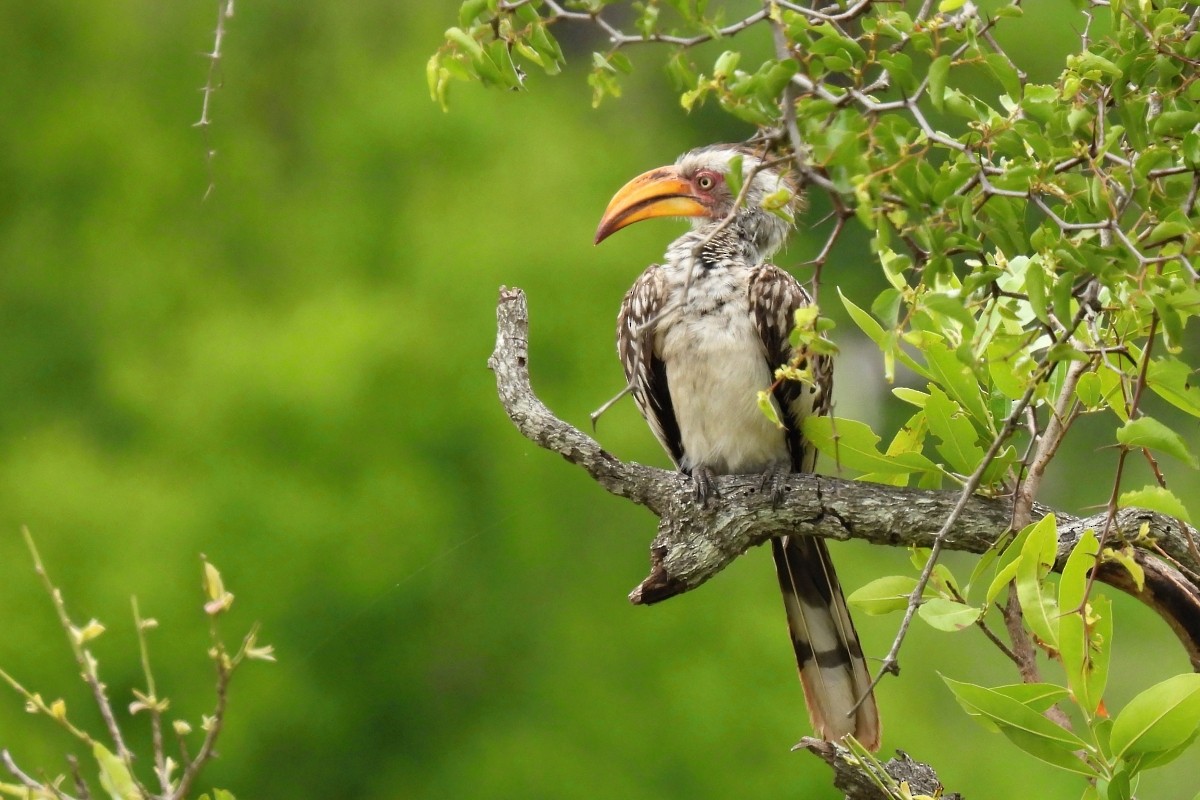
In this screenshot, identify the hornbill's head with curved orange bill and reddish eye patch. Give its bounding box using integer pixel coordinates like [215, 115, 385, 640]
[595, 144, 796, 254]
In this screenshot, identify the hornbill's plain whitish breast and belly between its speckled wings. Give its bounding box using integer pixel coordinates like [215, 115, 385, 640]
[656, 271, 788, 474]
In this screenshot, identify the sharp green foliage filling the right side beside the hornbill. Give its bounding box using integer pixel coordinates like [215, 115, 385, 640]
[431, 0, 1200, 798]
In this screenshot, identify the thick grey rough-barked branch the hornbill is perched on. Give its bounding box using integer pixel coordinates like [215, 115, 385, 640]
[488, 288, 1200, 669]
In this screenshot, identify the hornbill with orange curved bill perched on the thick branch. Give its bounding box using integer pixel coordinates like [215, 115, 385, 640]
[595, 144, 881, 751]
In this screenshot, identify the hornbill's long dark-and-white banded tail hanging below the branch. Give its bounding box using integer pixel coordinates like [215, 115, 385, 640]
[770, 536, 881, 751]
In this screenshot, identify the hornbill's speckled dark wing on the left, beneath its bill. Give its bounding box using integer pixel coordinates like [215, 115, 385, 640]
[617, 264, 683, 467]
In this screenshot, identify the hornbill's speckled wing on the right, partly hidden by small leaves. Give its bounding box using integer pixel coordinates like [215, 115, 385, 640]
[750, 264, 833, 473]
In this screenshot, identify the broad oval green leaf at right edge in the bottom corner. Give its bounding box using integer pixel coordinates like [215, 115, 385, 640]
[1110, 673, 1200, 758]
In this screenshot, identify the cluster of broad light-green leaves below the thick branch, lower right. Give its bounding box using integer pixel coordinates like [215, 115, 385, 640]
[850, 515, 1200, 800]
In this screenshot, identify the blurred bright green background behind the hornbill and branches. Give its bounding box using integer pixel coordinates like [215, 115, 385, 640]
[0, 0, 1196, 800]
